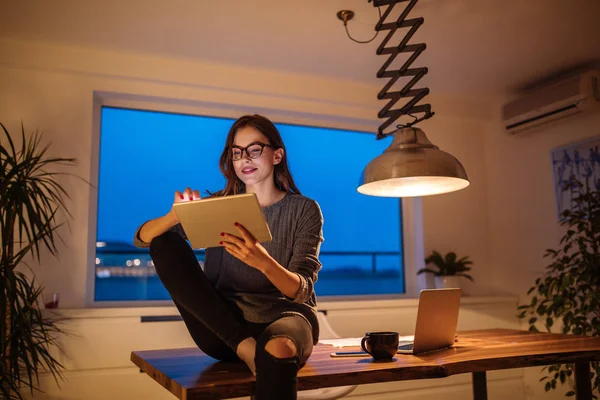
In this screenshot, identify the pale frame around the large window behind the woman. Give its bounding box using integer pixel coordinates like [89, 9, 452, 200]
[85, 92, 427, 308]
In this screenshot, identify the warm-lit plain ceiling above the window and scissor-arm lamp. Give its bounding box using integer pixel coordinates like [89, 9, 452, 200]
[0, 0, 600, 96]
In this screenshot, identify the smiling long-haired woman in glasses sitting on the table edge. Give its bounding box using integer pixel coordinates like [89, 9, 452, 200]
[134, 115, 323, 400]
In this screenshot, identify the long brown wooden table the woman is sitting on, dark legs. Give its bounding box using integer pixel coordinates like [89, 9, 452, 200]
[131, 329, 600, 400]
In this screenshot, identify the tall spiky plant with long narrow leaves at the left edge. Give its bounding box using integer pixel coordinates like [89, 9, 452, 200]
[0, 123, 75, 399]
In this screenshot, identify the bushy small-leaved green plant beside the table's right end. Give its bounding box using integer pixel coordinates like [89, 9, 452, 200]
[518, 180, 600, 398]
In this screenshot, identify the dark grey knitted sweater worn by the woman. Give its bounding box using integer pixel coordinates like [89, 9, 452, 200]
[134, 193, 323, 343]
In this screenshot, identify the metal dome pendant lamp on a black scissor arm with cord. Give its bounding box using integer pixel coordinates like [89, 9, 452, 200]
[337, 0, 469, 197]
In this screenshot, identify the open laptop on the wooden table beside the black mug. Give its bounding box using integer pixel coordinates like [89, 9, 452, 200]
[331, 288, 461, 357]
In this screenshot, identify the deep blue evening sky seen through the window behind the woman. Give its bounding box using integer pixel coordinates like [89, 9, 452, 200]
[97, 107, 401, 256]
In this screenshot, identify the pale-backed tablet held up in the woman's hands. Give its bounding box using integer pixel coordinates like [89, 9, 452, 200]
[173, 193, 273, 249]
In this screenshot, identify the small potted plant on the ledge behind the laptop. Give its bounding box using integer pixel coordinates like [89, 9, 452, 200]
[417, 250, 474, 289]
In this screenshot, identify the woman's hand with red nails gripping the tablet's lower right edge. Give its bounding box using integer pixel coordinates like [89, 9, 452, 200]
[221, 222, 273, 272]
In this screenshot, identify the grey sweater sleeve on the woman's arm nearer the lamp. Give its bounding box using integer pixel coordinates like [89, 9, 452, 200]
[288, 201, 323, 303]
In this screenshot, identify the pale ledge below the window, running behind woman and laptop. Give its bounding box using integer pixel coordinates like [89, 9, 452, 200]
[51, 296, 518, 319]
